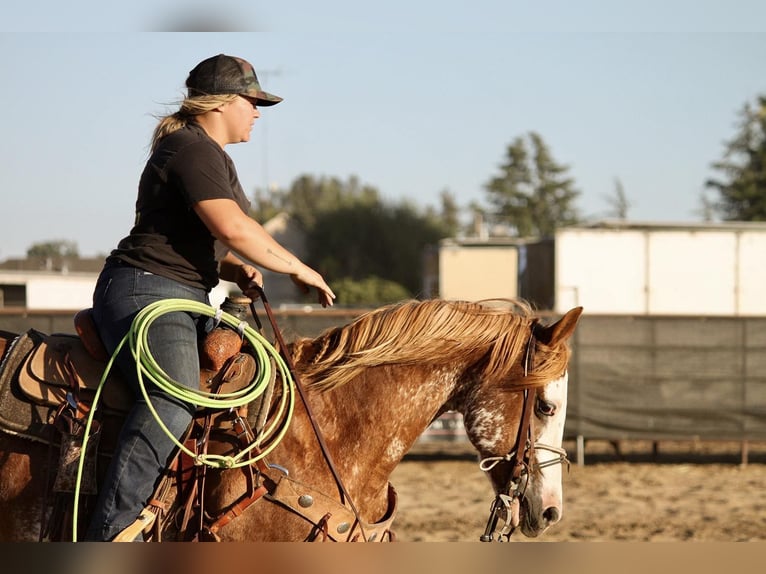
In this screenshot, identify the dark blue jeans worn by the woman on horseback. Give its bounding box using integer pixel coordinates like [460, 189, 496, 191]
[84, 263, 211, 541]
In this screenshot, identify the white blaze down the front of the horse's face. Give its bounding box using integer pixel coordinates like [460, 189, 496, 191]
[535, 373, 569, 520]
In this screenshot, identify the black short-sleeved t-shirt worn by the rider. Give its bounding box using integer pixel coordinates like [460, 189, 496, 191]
[110, 123, 250, 290]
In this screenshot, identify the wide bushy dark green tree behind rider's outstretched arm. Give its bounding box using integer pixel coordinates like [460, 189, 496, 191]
[251, 175, 459, 305]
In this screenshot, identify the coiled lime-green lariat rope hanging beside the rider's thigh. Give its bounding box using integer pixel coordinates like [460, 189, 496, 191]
[72, 299, 295, 542]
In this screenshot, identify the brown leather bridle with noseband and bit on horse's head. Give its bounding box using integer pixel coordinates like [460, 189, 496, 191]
[479, 323, 569, 542]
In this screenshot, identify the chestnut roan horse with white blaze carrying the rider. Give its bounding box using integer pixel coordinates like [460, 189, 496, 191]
[0, 299, 582, 541]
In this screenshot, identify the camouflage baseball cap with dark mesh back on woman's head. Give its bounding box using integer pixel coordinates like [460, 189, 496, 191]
[186, 54, 282, 106]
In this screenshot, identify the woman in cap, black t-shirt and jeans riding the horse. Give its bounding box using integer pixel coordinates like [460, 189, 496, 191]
[86, 54, 335, 540]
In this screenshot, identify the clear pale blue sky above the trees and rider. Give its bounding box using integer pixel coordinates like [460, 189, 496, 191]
[0, 0, 766, 260]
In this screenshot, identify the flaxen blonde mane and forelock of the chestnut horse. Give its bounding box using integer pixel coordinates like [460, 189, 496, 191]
[293, 299, 569, 391]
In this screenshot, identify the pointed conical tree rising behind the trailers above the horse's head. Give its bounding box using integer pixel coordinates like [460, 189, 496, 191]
[485, 132, 580, 237]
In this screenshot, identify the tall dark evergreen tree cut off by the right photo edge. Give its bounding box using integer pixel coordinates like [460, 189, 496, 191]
[705, 95, 766, 221]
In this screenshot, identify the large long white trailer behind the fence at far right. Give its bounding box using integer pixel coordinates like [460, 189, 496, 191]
[554, 222, 766, 316]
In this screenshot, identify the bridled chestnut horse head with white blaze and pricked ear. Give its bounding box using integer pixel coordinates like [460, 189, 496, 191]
[463, 307, 582, 541]
